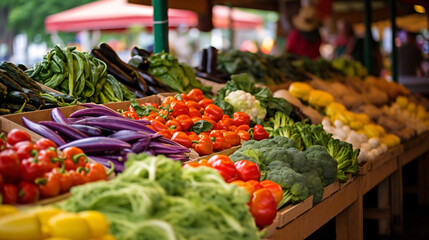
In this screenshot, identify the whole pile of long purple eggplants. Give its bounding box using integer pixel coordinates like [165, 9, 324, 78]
[18, 106, 189, 172]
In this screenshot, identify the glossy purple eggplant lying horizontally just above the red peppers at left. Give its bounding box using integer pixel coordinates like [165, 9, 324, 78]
[58, 137, 131, 153]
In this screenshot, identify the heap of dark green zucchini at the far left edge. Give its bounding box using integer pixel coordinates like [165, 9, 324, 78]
[0, 62, 76, 115]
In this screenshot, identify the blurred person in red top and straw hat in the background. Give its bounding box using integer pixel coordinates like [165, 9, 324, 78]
[286, 5, 322, 59]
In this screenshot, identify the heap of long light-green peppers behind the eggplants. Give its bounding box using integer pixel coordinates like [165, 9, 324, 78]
[25, 46, 135, 103]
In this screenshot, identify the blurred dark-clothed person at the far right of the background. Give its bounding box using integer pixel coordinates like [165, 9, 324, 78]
[398, 32, 423, 77]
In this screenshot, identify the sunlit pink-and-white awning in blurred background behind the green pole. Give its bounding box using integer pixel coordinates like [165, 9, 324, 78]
[45, 0, 263, 32]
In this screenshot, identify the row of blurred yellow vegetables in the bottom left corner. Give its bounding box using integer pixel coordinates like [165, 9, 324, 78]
[0, 205, 116, 240]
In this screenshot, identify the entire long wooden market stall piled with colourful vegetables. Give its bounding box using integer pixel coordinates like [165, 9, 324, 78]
[0, 39, 429, 239]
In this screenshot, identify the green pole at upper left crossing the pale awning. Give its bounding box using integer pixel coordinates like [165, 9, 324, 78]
[152, 0, 169, 53]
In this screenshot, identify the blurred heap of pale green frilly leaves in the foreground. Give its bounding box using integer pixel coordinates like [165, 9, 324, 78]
[61, 154, 259, 240]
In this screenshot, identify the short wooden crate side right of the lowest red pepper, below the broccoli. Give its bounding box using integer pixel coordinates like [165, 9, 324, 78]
[277, 196, 313, 228]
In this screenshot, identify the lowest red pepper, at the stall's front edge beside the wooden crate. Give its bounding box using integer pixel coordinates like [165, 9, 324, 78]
[250, 188, 277, 228]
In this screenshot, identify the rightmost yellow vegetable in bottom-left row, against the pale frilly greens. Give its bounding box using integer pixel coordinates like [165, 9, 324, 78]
[79, 211, 109, 238]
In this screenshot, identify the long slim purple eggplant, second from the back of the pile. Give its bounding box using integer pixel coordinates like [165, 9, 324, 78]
[76, 116, 155, 134]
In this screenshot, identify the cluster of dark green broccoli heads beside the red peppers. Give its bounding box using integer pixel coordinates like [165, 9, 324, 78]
[230, 136, 337, 208]
